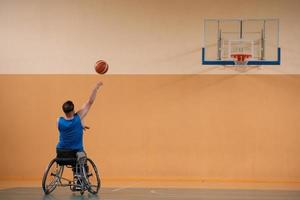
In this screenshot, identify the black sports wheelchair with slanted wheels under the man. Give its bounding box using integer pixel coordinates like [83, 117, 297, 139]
[42, 149, 101, 195]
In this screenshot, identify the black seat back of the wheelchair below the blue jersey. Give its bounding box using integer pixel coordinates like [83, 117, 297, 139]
[56, 149, 77, 166]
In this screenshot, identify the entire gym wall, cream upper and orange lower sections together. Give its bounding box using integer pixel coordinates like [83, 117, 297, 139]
[0, 0, 300, 185]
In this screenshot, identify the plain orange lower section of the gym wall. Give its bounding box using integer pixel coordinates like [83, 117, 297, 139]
[0, 75, 300, 186]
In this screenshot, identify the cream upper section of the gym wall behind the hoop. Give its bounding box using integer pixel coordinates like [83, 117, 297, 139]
[0, 0, 300, 74]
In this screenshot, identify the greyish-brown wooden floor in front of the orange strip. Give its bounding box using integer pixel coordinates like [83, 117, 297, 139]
[0, 187, 300, 200]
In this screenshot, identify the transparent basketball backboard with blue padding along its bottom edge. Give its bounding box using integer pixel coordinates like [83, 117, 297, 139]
[202, 19, 281, 65]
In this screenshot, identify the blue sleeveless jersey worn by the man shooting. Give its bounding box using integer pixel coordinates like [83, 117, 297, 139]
[56, 113, 83, 151]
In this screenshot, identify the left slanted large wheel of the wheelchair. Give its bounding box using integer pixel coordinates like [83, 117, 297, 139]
[42, 158, 64, 194]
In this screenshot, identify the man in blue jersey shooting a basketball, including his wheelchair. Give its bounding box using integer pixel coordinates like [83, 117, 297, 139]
[42, 82, 102, 194]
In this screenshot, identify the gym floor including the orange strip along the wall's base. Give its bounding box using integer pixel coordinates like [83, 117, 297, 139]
[0, 180, 300, 200]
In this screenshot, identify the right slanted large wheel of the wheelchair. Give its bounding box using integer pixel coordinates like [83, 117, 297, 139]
[83, 158, 101, 194]
